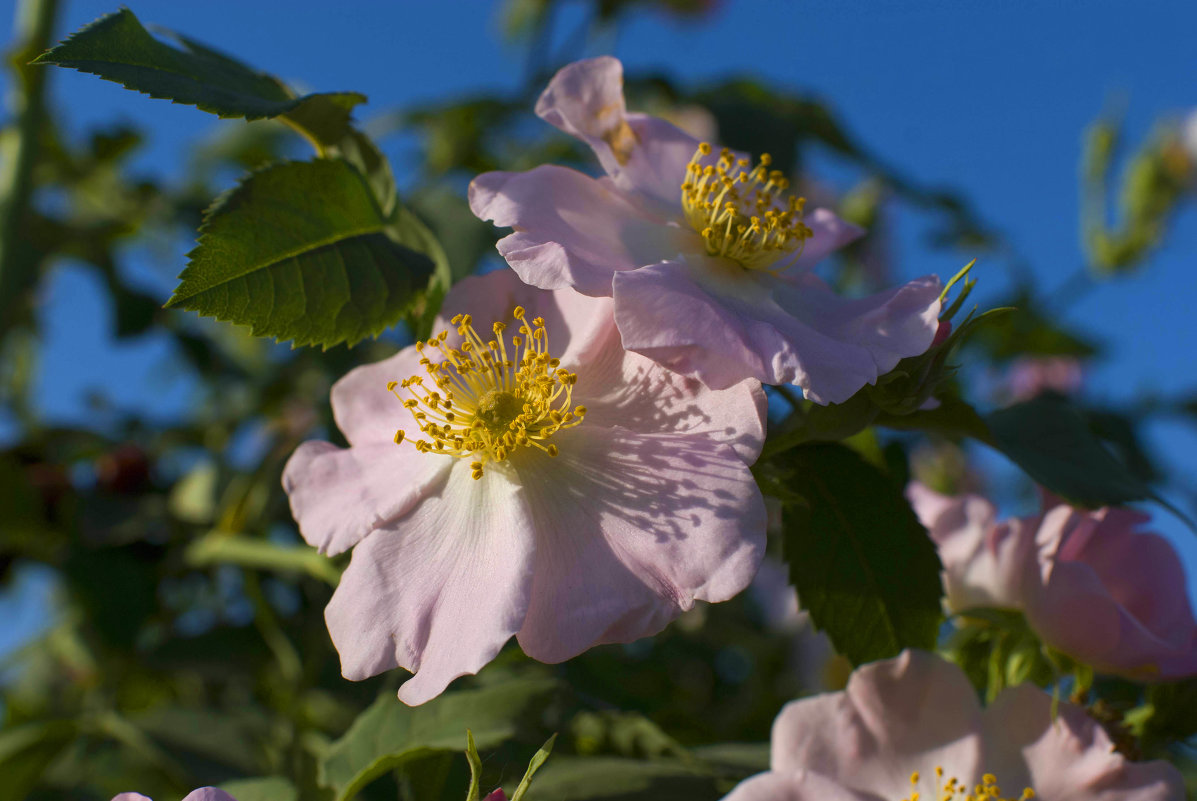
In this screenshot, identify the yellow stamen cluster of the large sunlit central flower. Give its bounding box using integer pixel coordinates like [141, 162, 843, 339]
[387, 307, 587, 479]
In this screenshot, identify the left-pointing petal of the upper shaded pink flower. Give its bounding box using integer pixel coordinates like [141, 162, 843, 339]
[469, 164, 697, 296]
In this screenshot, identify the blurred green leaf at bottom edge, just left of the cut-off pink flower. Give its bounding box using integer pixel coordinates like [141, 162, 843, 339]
[528, 757, 730, 801]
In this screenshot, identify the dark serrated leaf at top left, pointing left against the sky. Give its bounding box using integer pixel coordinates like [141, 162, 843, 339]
[34, 8, 366, 135]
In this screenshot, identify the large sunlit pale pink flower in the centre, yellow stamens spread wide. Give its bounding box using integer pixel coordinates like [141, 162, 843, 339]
[282, 271, 765, 704]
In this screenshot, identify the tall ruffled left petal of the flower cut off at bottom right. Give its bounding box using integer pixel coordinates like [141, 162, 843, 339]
[771, 651, 982, 799]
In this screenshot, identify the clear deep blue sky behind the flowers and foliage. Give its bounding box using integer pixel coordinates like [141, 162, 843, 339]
[0, 0, 1197, 646]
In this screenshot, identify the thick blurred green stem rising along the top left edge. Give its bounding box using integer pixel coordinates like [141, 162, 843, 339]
[0, 0, 59, 336]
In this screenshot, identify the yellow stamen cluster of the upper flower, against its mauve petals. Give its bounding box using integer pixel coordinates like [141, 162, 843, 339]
[681, 142, 810, 272]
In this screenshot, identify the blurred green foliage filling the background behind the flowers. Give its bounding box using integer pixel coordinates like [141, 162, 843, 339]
[7, 0, 1197, 801]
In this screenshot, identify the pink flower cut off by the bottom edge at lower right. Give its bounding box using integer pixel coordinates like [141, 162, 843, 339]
[727, 651, 1184, 801]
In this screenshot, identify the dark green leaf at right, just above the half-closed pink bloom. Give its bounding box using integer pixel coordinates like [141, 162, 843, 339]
[988, 395, 1155, 506]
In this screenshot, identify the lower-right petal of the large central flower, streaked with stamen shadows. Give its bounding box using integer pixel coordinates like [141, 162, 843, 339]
[519, 420, 765, 662]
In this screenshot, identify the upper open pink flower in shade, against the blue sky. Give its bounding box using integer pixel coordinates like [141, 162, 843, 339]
[469, 56, 940, 403]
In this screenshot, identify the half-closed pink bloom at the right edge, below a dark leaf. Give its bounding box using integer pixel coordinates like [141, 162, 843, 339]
[907, 484, 1197, 680]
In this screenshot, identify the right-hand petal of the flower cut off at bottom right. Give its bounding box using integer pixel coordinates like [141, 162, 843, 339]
[985, 685, 1184, 801]
